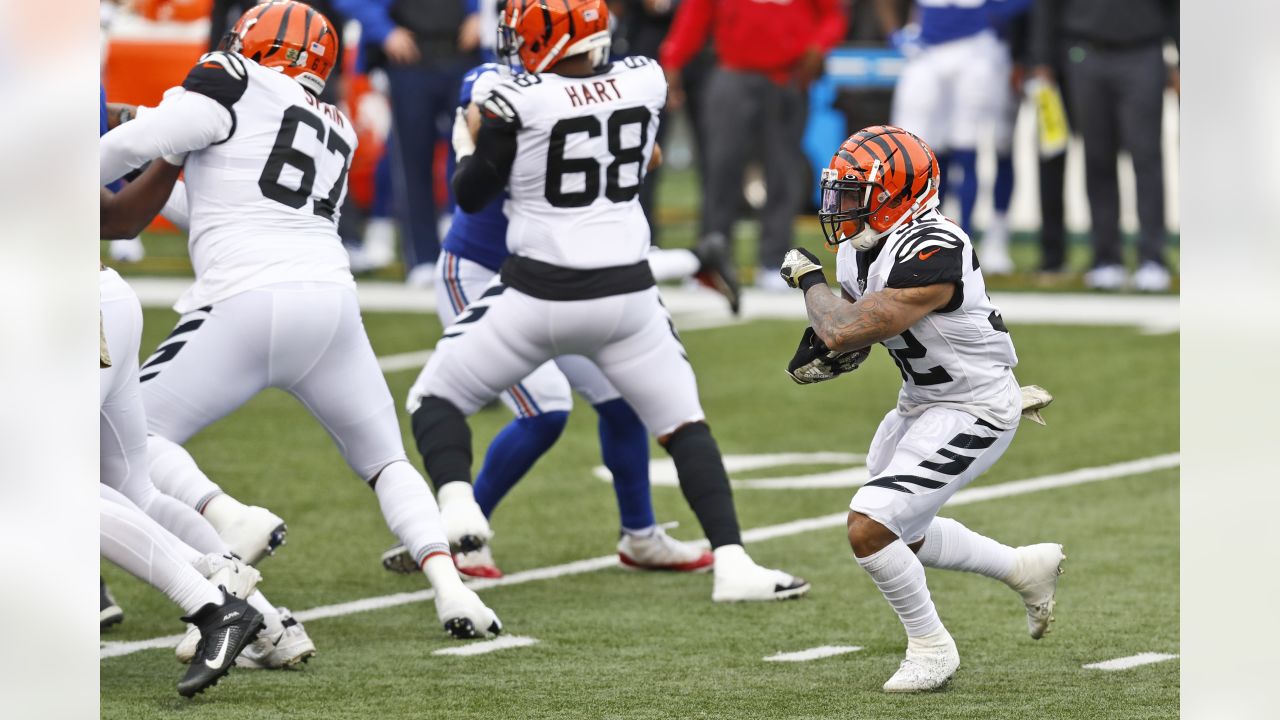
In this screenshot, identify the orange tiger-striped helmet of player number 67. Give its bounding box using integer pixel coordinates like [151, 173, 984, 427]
[219, 0, 338, 95]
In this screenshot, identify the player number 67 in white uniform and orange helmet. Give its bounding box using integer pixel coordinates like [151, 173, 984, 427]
[101, 1, 502, 638]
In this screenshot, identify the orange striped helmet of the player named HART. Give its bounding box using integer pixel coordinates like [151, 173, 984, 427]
[497, 0, 611, 73]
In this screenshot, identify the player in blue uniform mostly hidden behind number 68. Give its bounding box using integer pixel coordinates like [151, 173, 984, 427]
[383, 63, 739, 577]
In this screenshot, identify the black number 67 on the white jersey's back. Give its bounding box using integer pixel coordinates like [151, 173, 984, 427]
[257, 105, 351, 220]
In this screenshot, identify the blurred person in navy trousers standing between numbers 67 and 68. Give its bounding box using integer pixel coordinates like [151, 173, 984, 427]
[333, 0, 481, 286]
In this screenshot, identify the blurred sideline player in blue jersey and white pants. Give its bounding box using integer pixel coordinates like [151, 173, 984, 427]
[879, 0, 1030, 273]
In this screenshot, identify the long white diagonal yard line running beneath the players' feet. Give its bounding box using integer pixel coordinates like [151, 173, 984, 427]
[100, 452, 1179, 659]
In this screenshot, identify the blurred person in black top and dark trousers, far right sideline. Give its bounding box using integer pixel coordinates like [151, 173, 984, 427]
[1032, 0, 1179, 292]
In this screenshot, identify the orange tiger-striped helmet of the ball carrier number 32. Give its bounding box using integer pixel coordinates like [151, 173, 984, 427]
[818, 126, 940, 250]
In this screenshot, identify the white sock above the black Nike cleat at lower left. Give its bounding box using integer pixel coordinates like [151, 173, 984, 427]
[99, 488, 223, 615]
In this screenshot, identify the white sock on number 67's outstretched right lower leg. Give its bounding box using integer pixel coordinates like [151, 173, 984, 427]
[374, 460, 452, 568]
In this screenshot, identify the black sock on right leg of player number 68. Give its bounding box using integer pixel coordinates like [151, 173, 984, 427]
[667, 423, 742, 548]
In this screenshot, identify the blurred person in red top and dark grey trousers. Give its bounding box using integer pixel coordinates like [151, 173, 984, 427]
[659, 0, 846, 290]
